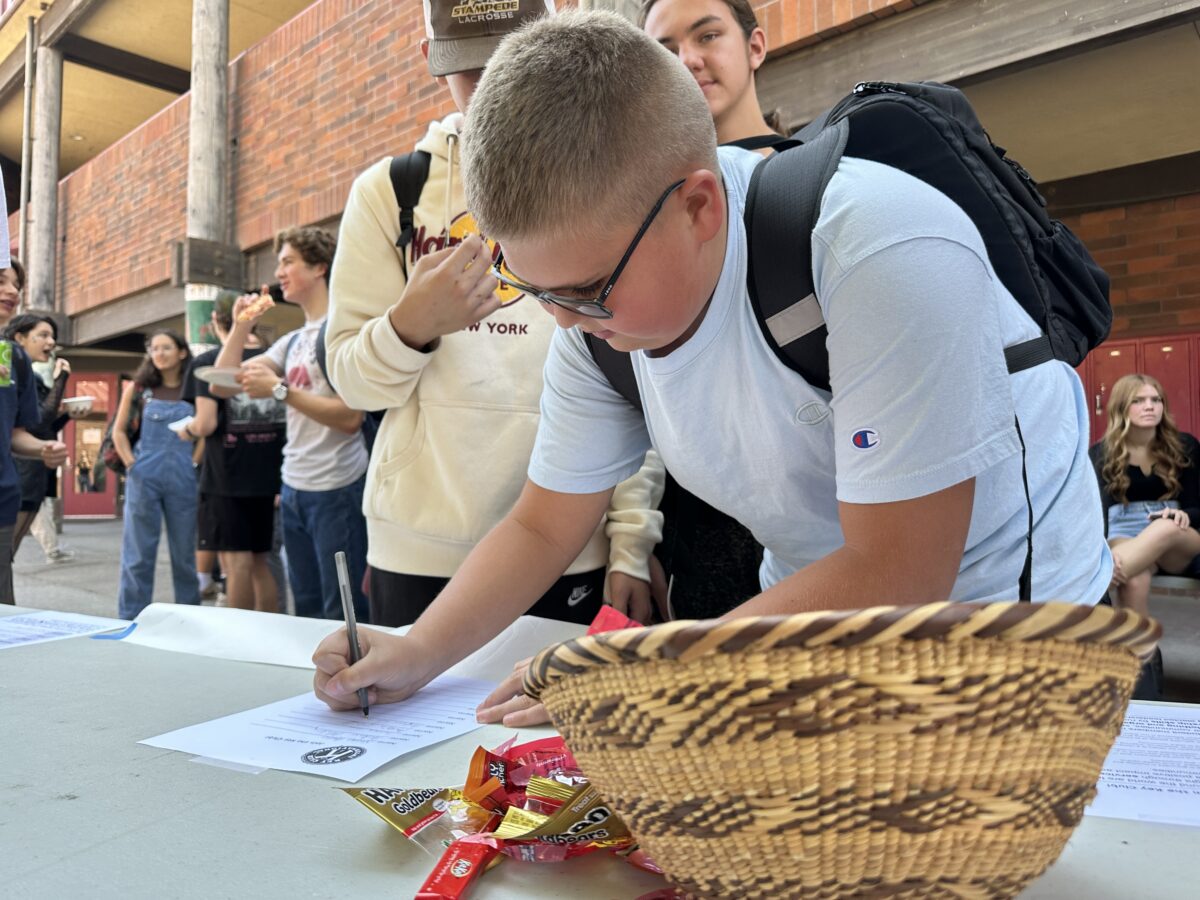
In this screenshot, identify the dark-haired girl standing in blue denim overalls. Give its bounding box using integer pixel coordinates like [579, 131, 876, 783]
[113, 329, 200, 619]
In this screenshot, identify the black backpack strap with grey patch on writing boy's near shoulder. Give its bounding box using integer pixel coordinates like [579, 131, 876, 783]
[745, 119, 850, 390]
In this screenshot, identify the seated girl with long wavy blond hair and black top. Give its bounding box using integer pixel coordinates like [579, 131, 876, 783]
[1090, 374, 1200, 614]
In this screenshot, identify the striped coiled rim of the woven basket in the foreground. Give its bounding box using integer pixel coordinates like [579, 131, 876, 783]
[523, 600, 1163, 700]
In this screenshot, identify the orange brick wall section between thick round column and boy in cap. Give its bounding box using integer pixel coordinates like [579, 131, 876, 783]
[232, 0, 454, 248]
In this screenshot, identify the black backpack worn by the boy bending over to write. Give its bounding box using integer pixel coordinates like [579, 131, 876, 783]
[587, 82, 1112, 600]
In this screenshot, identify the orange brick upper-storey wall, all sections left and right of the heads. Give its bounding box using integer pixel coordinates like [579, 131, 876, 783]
[51, 0, 923, 314]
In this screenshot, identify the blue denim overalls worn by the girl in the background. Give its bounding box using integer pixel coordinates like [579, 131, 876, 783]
[116, 391, 200, 619]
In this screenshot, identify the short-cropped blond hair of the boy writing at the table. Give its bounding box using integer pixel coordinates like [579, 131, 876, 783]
[462, 10, 718, 241]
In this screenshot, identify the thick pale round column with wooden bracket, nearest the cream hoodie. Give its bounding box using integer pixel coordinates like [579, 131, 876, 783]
[184, 0, 232, 346]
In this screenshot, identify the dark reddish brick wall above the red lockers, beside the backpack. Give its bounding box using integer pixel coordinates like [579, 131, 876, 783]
[1063, 194, 1200, 337]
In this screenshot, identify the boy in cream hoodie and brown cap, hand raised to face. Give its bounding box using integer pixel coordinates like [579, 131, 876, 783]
[326, 0, 661, 625]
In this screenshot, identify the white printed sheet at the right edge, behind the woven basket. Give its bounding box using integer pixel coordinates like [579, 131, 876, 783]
[1087, 703, 1200, 827]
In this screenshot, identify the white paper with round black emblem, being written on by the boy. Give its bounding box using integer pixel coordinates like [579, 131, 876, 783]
[139, 676, 494, 784]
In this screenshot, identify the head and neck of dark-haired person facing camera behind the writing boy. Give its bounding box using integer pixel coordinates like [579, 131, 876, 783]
[638, 0, 782, 149]
